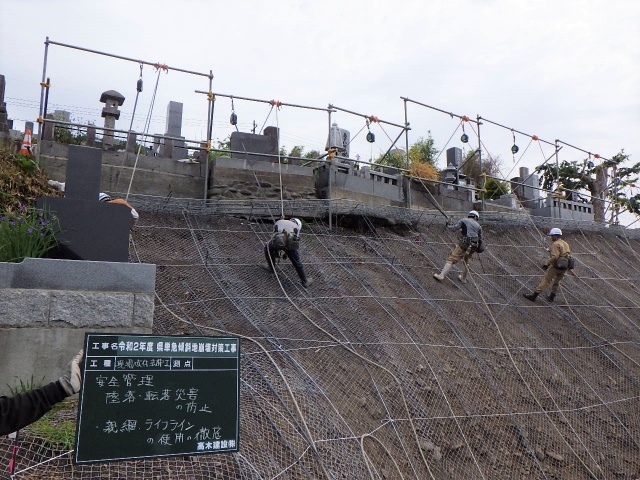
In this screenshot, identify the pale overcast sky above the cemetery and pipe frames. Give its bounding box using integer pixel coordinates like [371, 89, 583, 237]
[0, 0, 640, 194]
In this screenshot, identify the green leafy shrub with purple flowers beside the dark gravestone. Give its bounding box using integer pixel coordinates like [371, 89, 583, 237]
[0, 205, 59, 263]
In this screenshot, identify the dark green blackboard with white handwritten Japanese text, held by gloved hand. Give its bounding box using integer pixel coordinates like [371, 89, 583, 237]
[74, 333, 240, 463]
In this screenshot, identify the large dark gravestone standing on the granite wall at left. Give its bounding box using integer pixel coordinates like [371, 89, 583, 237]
[37, 145, 131, 262]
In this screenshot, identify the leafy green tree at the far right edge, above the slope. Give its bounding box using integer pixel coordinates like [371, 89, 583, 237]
[535, 149, 640, 223]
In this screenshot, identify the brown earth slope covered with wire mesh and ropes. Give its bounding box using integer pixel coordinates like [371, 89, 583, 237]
[2, 212, 640, 480]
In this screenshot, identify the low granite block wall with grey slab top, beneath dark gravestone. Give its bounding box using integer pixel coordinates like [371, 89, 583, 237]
[0, 258, 155, 394]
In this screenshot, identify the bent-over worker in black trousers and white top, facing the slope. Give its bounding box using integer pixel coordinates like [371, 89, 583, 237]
[264, 218, 313, 288]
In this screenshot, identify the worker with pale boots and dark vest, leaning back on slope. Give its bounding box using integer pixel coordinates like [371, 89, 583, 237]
[433, 210, 484, 283]
